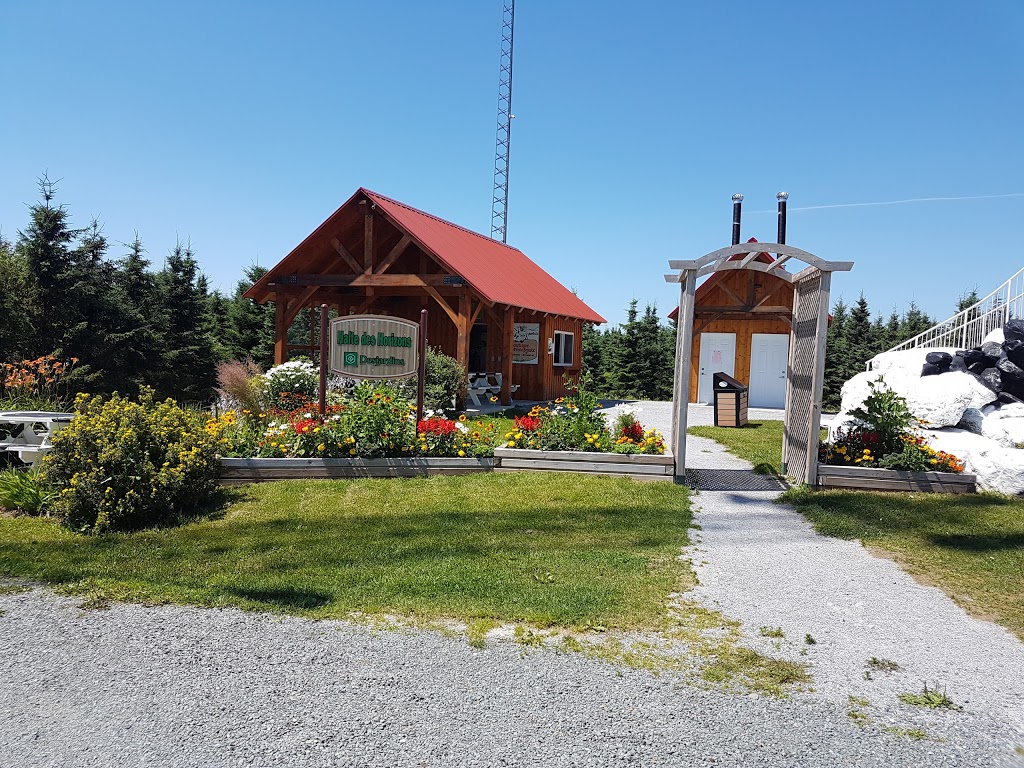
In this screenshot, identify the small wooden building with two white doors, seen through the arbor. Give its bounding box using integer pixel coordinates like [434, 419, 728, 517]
[669, 238, 794, 408]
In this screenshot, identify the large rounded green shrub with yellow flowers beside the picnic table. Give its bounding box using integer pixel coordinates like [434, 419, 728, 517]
[43, 389, 217, 532]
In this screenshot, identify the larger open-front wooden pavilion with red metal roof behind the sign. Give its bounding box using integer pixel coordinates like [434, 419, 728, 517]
[245, 187, 605, 403]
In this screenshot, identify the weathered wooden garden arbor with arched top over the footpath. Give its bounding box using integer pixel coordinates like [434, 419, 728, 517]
[665, 243, 853, 484]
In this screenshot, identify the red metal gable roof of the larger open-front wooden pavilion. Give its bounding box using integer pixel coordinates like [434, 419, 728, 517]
[246, 187, 605, 323]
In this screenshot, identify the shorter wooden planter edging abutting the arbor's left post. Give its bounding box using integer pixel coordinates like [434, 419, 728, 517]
[495, 449, 675, 480]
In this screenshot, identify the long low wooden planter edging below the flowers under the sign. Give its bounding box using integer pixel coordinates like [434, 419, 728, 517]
[219, 458, 496, 485]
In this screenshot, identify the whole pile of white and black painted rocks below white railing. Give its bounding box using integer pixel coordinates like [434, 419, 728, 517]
[829, 321, 1024, 495]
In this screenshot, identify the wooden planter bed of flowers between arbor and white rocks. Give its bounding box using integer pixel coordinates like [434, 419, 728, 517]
[817, 377, 977, 494]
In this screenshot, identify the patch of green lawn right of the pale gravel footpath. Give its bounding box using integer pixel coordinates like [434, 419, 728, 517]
[782, 488, 1024, 640]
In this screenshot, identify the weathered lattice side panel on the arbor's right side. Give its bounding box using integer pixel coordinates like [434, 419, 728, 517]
[785, 271, 827, 482]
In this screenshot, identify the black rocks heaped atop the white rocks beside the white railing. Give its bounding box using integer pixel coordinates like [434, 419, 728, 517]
[921, 319, 1024, 403]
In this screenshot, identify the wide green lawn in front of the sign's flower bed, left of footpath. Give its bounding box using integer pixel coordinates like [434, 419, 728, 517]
[0, 473, 692, 628]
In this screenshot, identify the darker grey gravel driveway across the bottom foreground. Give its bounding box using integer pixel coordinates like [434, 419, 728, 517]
[0, 590, 1011, 768]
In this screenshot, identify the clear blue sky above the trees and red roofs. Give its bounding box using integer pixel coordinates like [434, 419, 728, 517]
[0, 0, 1024, 323]
